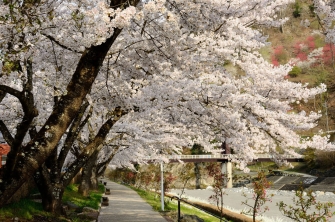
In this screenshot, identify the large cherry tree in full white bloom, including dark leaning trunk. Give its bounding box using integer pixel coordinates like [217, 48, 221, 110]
[0, 0, 331, 211]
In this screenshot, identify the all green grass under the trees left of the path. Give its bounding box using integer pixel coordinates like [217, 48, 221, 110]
[0, 184, 104, 221]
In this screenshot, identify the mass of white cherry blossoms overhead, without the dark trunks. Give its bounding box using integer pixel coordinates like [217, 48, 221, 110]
[0, 0, 332, 169]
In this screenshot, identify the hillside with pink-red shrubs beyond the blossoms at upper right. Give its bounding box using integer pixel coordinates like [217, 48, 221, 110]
[260, 0, 335, 135]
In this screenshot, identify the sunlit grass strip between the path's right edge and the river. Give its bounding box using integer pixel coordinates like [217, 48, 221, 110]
[131, 187, 223, 222]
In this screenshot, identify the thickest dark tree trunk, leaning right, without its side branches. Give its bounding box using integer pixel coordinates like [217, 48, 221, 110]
[0, 13, 133, 208]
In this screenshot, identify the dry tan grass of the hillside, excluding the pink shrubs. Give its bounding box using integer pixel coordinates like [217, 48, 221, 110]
[260, 0, 335, 136]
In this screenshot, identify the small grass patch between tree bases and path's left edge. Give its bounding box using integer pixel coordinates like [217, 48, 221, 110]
[63, 184, 105, 209]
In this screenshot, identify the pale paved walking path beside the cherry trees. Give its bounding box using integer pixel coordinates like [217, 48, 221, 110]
[98, 180, 166, 222]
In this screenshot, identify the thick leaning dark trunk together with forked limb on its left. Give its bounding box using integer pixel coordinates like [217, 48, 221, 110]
[0, 0, 139, 207]
